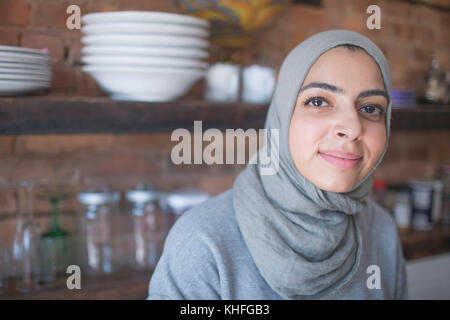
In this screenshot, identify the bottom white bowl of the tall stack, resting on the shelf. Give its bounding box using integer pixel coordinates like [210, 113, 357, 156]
[82, 65, 205, 102]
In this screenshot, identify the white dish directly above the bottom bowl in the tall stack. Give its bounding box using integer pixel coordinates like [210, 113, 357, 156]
[81, 55, 208, 69]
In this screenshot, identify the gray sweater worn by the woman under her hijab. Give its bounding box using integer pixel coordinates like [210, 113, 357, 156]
[148, 190, 407, 300]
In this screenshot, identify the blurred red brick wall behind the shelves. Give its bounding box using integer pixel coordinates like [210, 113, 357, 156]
[0, 0, 450, 241]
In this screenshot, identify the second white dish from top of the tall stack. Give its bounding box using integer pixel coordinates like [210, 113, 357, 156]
[81, 22, 209, 38]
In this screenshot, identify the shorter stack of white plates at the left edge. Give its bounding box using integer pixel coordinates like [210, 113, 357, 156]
[0, 46, 52, 96]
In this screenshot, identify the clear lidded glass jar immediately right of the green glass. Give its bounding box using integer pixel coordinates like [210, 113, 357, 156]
[78, 187, 120, 275]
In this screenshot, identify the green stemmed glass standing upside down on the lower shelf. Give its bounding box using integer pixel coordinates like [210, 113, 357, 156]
[38, 186, 73, 282]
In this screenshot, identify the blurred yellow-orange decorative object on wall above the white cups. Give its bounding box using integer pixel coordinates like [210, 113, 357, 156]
[175, 0, 288, 49]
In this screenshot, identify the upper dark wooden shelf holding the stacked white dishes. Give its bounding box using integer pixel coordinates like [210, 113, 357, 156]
[0, 96, 450, 135]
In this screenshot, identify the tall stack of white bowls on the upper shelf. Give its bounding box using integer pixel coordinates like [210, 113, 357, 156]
[81, 11, 210, 101]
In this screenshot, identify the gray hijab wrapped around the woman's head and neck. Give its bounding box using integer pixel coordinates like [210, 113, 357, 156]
[233, 30, 391, 299]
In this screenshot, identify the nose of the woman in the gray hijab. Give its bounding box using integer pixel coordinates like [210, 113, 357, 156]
[334, 107, 363, 141]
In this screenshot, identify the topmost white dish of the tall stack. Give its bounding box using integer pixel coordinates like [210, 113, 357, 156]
[81, 11, 209, 28]
